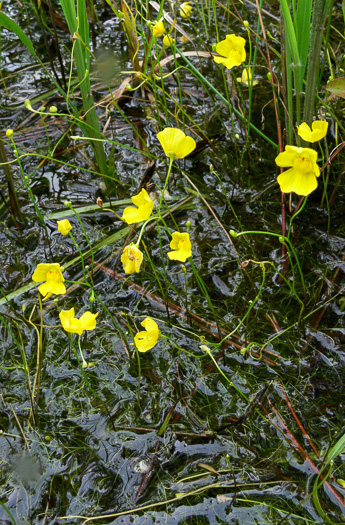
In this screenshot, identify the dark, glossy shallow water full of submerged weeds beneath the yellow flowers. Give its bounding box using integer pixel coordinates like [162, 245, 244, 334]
[0, 2, 345, 525]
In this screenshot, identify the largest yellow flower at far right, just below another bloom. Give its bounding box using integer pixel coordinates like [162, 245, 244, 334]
[276, 146, 320, 196]
